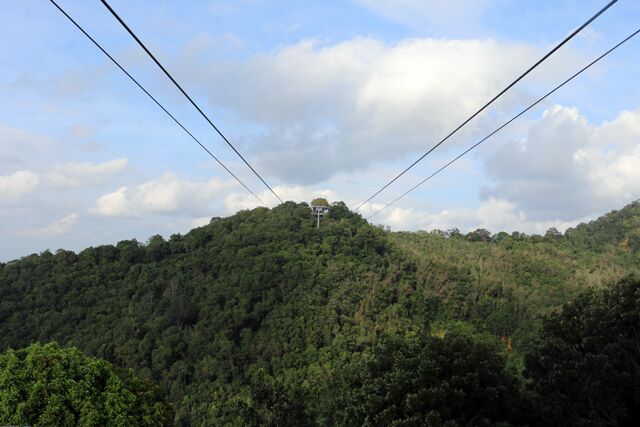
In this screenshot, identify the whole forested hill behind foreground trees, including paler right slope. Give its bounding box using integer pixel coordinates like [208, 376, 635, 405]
[0, 202, 640, 425]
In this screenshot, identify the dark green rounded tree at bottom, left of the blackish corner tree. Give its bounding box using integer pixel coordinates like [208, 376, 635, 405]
[343, 333, 521, 426]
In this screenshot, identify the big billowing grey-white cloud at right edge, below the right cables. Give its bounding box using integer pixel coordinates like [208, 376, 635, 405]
[482, 106, 640, 220]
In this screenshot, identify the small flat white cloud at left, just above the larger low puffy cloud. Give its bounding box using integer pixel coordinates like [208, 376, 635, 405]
[45, 158, 128, 189]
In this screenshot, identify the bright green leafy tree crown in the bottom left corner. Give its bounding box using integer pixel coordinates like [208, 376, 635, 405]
[0, 343, 172, 426]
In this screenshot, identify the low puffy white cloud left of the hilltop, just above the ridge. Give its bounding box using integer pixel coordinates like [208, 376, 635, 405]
[90, 173, 236, 217]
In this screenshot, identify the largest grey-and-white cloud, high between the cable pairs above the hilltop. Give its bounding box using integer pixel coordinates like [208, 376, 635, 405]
[176, 38, 576, 184]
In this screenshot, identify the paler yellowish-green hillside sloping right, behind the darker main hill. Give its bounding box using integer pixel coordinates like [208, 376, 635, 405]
[389, 202, 640, 349]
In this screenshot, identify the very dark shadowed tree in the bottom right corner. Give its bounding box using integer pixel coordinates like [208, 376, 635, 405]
[525, 278, 640, 426]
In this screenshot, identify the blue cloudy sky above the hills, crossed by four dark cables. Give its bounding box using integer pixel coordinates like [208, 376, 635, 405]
[0, 0, 640, 261]
